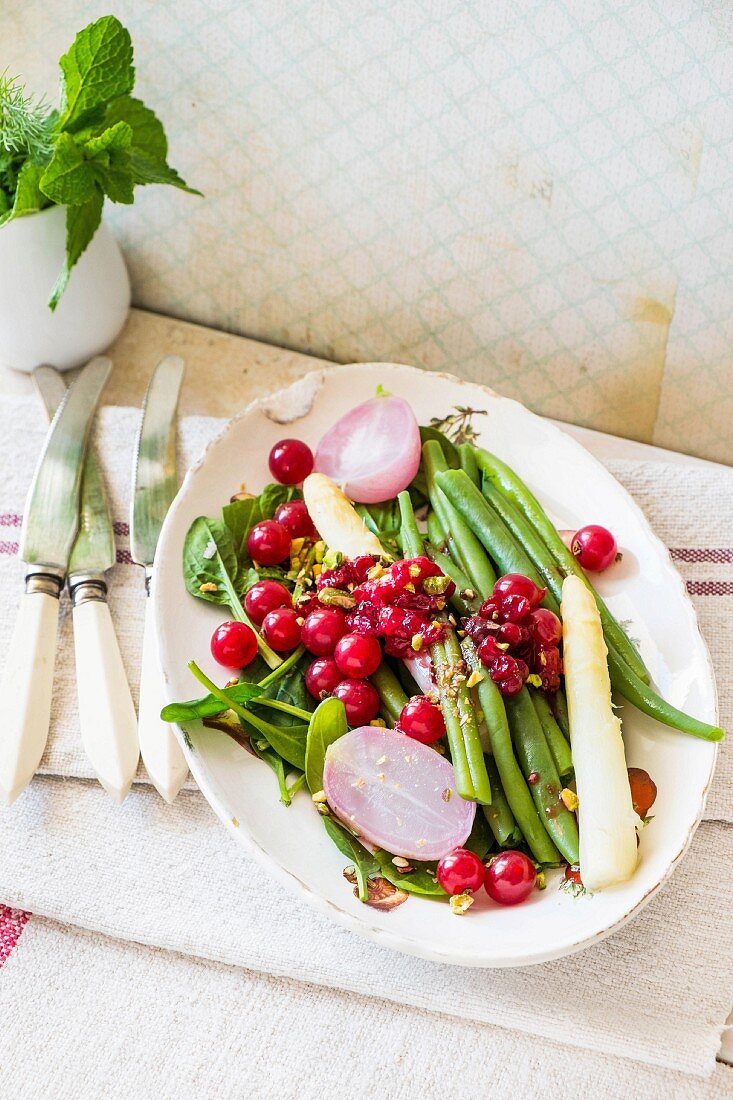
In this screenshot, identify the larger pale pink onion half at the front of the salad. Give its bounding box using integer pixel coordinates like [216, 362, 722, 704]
[324, 726, 475, 860]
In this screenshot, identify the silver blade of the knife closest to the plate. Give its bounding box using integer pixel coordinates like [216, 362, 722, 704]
[130, 355, 185, 569]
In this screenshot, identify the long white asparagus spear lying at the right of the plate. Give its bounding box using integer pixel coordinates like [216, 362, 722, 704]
[561, 576, 639, 891]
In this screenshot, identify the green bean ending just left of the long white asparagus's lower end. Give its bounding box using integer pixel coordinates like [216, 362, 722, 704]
[504, 688, 579, 864]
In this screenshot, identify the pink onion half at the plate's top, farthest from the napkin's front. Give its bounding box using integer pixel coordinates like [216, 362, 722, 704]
[315, 397, 420, 504]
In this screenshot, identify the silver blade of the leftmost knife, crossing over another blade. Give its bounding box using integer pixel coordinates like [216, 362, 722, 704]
[19, 355, 112, 572]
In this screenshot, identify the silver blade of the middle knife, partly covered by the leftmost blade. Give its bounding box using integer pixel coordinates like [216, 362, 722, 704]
[33, 364, 116, 578]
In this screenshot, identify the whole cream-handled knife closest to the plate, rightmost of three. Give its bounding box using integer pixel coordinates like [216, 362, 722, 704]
[130, 355, 188, 802]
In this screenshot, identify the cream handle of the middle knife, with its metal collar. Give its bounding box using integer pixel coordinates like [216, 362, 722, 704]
[73, 583, 140, 802]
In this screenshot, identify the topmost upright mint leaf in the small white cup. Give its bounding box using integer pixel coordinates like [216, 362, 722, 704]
[58, 15, 135, 130]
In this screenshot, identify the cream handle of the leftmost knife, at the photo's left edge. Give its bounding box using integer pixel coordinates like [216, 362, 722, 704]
[0, 575, 62, 806]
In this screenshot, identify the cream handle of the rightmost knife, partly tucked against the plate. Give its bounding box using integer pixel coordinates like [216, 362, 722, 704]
[138, 596, 188, 802]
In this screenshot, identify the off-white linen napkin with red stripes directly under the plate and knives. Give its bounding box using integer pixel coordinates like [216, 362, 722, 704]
[0, 402, 733, 1074]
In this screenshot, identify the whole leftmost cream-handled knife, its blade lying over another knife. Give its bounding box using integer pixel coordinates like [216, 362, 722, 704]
[0, 356, 112, 805]
